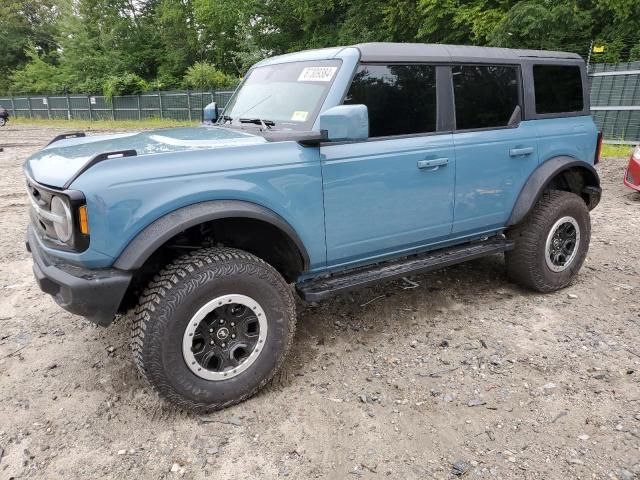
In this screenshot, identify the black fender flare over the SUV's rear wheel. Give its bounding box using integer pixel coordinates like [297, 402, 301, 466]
[507, 155, 601, 227]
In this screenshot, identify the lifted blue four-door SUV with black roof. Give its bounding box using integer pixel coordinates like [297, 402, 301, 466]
[24, 43, 601, 411]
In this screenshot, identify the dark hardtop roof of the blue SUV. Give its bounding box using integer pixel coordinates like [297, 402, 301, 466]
[353, 42, 583, 63]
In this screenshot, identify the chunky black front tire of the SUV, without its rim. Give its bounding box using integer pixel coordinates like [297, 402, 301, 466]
[131, 248, 296, 412]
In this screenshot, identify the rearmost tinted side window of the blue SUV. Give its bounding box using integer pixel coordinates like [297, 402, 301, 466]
[533, 65, 584, 114]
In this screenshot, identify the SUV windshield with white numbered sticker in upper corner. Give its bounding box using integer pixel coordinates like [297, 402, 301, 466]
[220, 60, 341, 130]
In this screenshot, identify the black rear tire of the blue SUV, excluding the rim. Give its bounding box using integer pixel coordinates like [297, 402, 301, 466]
[505, 190, 591, 292]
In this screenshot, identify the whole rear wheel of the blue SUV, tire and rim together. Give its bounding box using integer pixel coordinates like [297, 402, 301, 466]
[505, 190, 591, 292]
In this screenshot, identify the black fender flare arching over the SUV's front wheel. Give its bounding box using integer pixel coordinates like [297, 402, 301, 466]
[113, 200, 309, 270]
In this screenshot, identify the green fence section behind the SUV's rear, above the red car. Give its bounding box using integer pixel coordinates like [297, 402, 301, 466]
[589, 62, 640, 143]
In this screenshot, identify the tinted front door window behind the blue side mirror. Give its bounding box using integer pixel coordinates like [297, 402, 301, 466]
[344, 65, 436, 137]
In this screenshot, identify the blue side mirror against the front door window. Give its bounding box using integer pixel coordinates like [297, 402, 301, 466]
[320, 105, 369, 141]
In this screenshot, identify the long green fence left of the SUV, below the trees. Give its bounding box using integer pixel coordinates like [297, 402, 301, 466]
[0, 91, 233, 121]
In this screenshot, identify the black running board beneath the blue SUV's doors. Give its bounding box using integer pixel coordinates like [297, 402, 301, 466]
[296, 237, 513, 301]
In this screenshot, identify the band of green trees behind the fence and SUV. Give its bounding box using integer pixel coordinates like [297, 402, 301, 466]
[0, 0, 640, 93]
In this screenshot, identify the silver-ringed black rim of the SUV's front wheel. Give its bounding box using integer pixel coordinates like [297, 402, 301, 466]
[182, 294, 267, 380]
